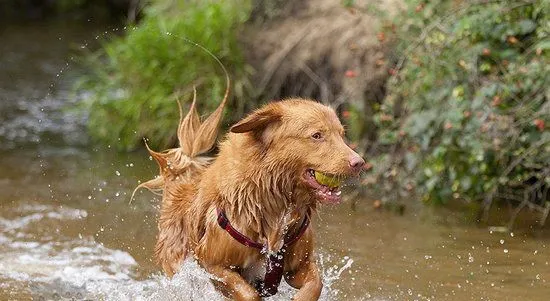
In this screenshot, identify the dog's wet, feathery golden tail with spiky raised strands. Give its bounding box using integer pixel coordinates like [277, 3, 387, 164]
[130, 82, 230, 202]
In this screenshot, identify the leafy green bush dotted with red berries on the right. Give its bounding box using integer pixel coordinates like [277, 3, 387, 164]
[375, 0, 550, 203]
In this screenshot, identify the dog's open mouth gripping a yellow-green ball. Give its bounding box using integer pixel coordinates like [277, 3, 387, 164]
[304, 169, 343, 204]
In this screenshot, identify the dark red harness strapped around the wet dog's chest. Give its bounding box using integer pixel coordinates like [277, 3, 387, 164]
[217, 209, 309, 297]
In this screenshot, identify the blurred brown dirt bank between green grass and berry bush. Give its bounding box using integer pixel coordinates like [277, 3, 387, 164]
[242, 0, 401, 141]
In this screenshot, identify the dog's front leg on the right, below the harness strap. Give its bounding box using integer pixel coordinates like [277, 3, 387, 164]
[285, 260, 323, 301]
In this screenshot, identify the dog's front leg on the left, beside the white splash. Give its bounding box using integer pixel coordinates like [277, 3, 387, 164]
[203, 265, 261, 301]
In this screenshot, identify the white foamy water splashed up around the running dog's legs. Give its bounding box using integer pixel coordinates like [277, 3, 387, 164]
[0, 204, 353, 301]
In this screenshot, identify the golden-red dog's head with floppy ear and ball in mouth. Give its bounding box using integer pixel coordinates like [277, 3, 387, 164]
[231, 99, 365, 204]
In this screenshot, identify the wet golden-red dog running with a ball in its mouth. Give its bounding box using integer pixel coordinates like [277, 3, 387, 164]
[134, 91, 365, 301]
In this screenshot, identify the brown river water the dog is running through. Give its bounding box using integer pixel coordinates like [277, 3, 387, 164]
[0, 21, 550, 300]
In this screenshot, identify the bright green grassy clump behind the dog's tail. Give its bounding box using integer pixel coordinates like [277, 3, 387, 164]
[77, 0, 254, 150]
